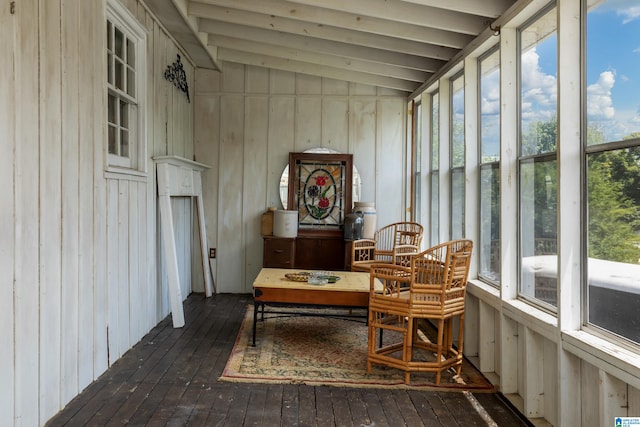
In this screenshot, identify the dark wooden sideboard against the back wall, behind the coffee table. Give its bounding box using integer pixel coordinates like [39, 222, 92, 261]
[262, 233, 345, 271]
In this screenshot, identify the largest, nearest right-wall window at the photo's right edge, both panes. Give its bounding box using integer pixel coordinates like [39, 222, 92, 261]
[585, 0, 640, 343]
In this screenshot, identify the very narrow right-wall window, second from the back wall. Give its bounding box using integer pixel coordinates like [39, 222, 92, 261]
[429, 92, 440, 246]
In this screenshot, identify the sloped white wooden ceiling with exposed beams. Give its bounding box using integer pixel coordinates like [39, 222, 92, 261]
[147, 0, 528, 93]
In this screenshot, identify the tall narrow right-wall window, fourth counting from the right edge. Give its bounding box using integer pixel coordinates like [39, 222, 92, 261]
[450, 74, 465, 239]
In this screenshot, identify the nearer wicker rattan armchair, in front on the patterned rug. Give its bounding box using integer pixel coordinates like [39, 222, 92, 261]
[367, 240, 473, 385]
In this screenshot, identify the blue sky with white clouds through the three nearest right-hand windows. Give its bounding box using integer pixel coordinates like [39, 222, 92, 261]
[483, 0, 640, 154]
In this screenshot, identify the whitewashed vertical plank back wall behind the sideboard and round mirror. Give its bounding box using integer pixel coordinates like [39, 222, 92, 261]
[194, 63, 407, 292]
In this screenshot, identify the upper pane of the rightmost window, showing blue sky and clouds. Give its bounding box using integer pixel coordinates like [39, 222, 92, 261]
[586, 0, 640, 145]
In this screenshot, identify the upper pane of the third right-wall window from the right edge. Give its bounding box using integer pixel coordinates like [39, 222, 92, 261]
[480, 50, 500, 163]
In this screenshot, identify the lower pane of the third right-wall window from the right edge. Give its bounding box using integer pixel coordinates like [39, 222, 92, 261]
[479, 163, 500, 282]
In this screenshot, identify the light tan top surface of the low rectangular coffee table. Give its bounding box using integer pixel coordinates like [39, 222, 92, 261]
[253, 268, 382, 292]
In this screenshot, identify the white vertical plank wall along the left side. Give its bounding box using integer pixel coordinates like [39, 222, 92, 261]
[0, 0, 195, 426]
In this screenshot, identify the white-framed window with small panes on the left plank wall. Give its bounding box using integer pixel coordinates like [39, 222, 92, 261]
[106, 1, 146, 172]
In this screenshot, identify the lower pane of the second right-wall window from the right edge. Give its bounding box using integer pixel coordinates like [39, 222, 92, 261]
[520, 160, 558, 306]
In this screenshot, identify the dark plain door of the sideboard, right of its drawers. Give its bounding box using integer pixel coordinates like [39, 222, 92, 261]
[295, 236, 344, 270]
